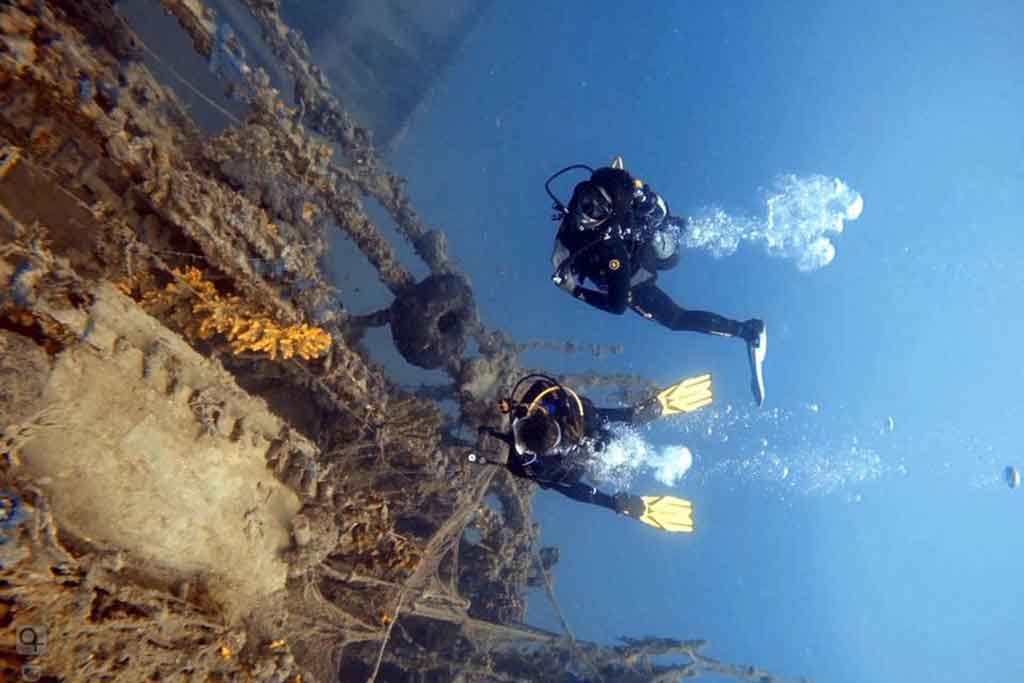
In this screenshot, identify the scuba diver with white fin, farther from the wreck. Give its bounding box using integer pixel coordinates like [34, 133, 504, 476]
[544, 157, 768, 407]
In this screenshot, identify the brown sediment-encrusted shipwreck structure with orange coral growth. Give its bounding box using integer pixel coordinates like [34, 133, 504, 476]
[0, 0, 790, 682]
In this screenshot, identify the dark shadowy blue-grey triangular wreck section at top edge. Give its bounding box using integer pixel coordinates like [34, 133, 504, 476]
[282, 0, 493, 147]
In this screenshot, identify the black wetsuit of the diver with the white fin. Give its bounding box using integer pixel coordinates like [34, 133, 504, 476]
[555, 168, 743, 337]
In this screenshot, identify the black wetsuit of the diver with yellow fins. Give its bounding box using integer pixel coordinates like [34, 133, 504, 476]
[480, 380, 635, 510]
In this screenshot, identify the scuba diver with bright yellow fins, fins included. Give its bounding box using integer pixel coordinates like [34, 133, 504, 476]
[469, 374, 713, 532]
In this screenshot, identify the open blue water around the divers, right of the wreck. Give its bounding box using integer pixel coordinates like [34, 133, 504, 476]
[317, 0, 1024, 683]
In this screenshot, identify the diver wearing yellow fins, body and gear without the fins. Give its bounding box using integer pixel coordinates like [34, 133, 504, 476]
[479, 375, 660, 517]
